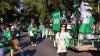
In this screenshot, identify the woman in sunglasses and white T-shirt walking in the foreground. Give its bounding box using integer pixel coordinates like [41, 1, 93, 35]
[55, 24, 71, 56]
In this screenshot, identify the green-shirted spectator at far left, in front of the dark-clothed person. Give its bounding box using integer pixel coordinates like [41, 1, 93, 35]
[3, 27, 14, 55]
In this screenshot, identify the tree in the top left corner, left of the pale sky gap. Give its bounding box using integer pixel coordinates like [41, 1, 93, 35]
[0, 0, 17, 21]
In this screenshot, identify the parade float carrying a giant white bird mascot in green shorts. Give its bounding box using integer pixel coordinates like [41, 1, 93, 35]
[69, 1, 100, 51]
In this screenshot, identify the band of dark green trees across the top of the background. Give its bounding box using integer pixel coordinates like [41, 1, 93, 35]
[0, 0, 97, 22]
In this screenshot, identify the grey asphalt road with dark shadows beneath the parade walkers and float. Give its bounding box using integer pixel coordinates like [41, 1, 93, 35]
[12, 33, 100, 56]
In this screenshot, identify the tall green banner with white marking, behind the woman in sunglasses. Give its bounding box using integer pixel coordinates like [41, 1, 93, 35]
[52, 11, 60, 32]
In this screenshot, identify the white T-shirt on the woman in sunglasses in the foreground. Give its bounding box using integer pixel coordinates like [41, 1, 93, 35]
[56, 32, 71, 53]
